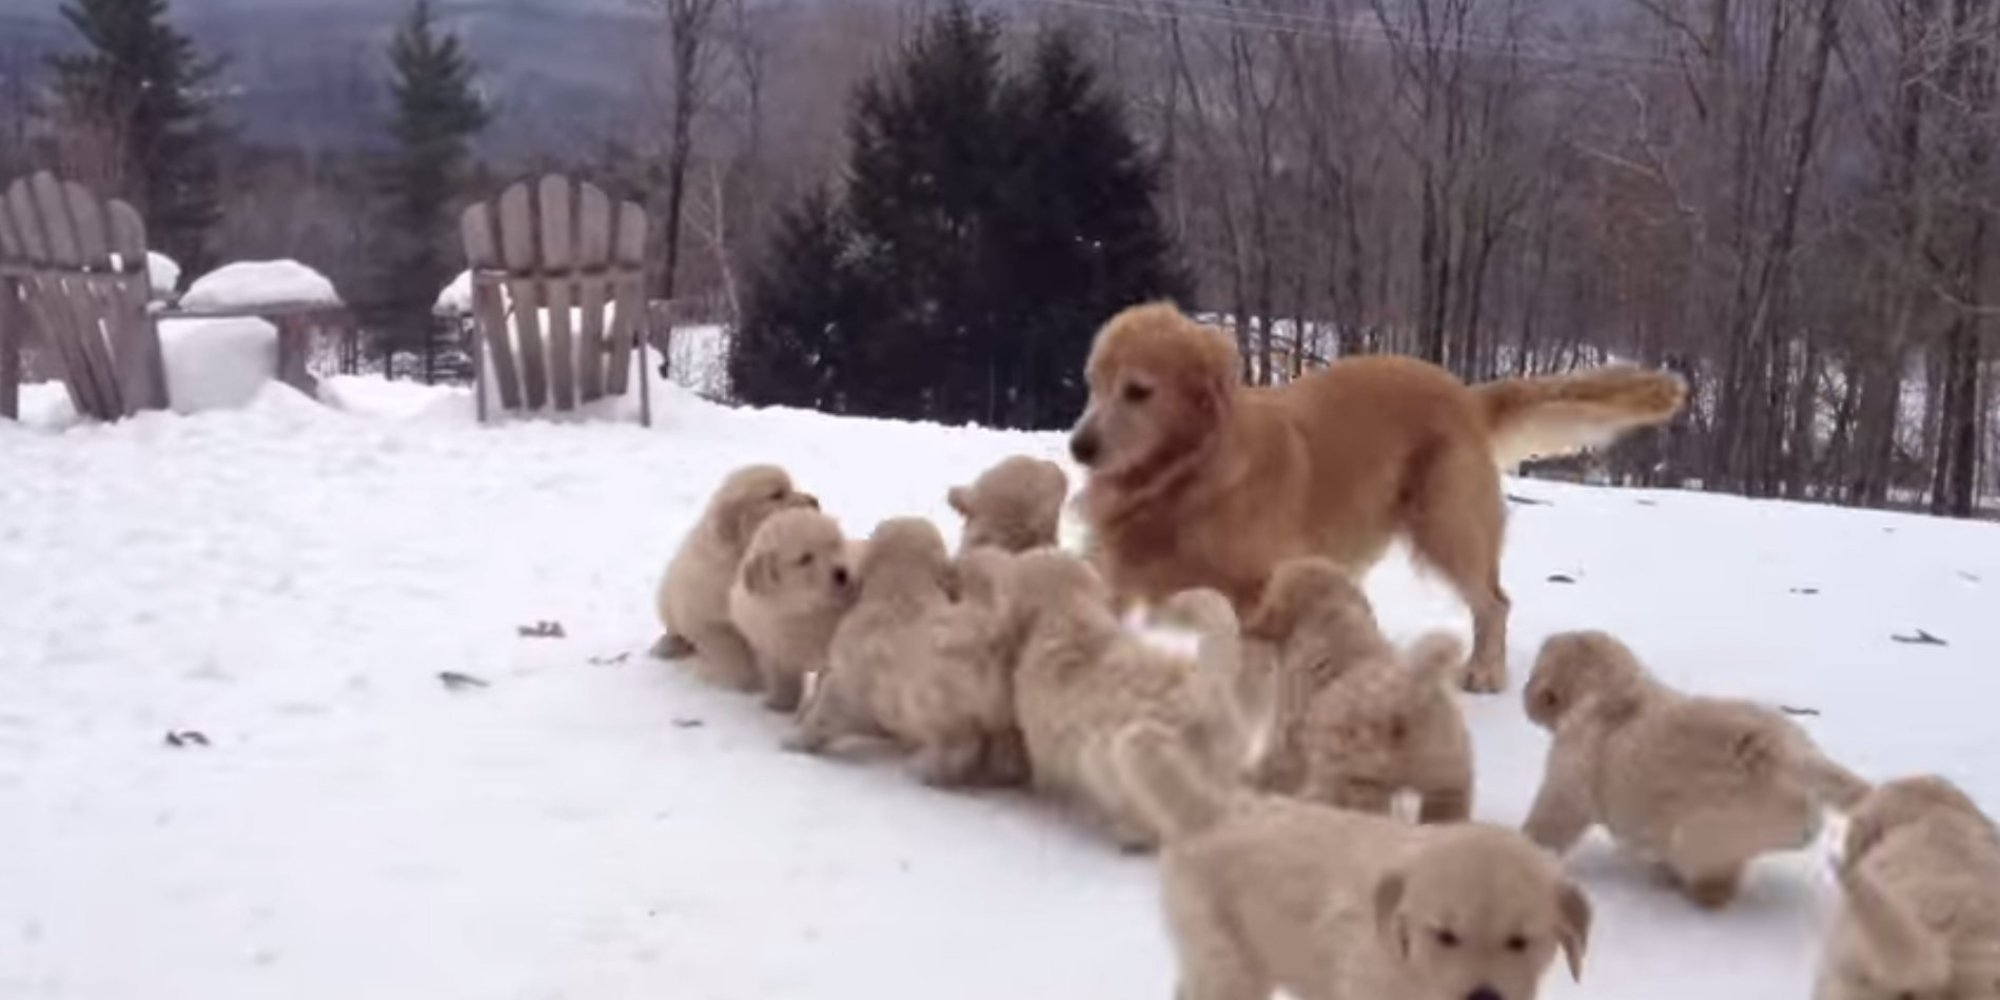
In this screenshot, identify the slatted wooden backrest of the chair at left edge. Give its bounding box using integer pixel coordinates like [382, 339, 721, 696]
[0, 172, 168, 420]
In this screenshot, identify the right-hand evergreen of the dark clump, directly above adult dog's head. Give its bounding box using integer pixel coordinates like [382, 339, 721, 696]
[988, 30, 1190, 428]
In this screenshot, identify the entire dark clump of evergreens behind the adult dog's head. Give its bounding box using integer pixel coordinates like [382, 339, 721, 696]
[732, 2, 1186, 426]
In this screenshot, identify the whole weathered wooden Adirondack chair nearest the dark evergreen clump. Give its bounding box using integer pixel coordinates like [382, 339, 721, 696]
[460, 174, 652, 426]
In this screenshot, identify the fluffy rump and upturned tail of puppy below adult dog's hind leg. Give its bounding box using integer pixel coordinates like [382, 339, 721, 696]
[1296, 632, 1472, 822]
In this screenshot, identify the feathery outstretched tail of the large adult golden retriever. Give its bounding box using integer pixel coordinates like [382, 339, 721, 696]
[1472, 364, 1688, 468]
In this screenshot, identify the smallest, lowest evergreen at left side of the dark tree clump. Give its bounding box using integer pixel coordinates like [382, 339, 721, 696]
[730, 192, 868, 414]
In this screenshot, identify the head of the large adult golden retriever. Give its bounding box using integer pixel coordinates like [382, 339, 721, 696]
[1070, 302, 1238, 478]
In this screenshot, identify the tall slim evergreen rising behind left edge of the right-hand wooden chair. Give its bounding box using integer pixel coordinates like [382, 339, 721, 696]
[376, 0, 490, 382]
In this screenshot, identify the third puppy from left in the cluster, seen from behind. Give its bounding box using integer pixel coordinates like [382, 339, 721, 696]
[788, 518, 1014, 786]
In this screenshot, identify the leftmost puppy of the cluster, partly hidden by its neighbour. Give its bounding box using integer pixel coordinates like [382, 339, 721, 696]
[654, 466, 820, 690]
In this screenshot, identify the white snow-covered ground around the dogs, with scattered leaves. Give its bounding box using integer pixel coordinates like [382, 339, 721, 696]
[0, 378, 2000, 1000]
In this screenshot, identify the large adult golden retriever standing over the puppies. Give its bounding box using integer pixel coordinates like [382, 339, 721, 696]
[1070, 304, 1686, 692]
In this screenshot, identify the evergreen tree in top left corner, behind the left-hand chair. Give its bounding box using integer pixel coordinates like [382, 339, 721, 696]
[50, 0, 224, 272]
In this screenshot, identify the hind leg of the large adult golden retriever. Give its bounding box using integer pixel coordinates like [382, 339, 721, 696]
[1406, 444, 1512, 694]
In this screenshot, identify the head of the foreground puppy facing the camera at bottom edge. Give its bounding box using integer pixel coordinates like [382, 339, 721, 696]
[1374, 824, 1590, 1000]
